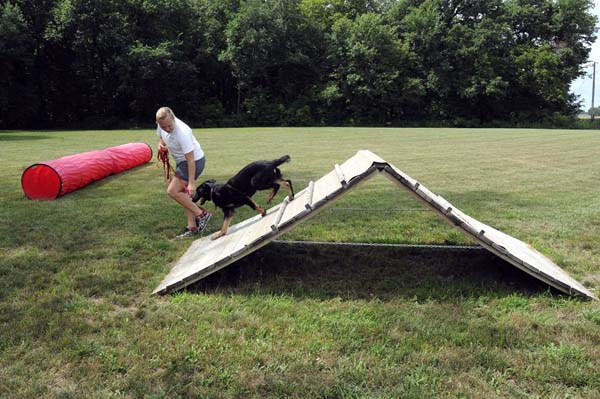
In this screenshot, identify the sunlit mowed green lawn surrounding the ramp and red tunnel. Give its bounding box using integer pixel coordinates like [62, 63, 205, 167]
[0, 128, 600, 398]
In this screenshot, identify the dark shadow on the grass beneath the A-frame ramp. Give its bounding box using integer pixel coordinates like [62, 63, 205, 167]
[188, 243, 561, 300]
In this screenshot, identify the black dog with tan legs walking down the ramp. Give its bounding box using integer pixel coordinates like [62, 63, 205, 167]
[192, 155, 294, 240]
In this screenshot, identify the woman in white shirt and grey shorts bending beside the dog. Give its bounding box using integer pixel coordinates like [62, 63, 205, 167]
[156, 107, 212, 238]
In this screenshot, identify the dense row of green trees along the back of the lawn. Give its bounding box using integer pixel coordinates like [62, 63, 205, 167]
[0, 0, 597, 129]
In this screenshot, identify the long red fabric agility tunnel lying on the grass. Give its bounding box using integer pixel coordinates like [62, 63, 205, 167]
[21, 143, 152, 200]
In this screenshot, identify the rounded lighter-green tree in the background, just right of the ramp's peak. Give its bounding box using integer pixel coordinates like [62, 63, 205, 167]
[321, 13, 415, 124]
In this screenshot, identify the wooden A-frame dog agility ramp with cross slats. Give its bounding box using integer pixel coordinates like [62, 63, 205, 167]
[153, 150, 598, 300]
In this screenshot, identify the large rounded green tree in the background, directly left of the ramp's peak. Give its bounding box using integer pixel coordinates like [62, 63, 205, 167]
[221, 0, 323, 124]
